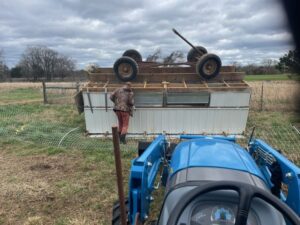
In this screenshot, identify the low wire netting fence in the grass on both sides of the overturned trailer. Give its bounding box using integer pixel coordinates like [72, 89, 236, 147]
[0, 104, 300, 164]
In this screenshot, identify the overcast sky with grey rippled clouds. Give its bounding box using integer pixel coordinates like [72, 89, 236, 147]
[0, 0, 293, 68]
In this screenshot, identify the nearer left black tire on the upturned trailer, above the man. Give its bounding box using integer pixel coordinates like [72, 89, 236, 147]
[113, 56, 139, 82]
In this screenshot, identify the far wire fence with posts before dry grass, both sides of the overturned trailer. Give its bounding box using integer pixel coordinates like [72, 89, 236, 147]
[0, 81, 300, 111]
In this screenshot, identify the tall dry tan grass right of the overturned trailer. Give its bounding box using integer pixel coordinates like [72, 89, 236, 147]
[248, 81, 300, 111]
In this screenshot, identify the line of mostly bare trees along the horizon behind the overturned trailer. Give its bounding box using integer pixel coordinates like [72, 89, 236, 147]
[0, 46, 300, 81]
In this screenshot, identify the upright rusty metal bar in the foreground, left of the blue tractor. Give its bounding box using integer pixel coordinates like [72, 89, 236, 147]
[112, 127, 127, 225]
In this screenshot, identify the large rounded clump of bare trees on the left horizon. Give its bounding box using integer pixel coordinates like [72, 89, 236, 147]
[19, 46, 75, 81]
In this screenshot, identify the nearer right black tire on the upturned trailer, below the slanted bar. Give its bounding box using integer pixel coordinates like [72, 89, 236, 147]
[196, 53, 222, 80]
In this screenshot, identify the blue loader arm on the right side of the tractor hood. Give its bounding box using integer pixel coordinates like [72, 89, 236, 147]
[249, 139, 300, 216]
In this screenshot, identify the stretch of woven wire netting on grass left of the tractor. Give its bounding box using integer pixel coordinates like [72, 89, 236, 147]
[0, 104, 142, 151]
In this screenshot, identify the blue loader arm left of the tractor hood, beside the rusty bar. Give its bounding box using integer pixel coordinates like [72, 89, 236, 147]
[129, 135, 167, 225]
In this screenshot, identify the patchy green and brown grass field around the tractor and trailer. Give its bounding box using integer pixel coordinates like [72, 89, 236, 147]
[0, 85, 300, 225]
